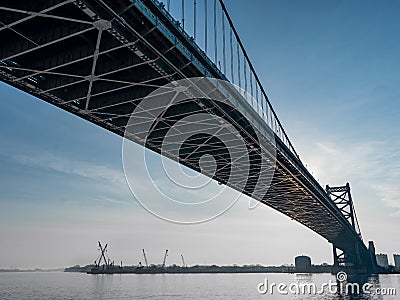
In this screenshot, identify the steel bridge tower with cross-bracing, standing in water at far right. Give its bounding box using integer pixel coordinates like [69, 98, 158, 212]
[326, 183, 376, 273]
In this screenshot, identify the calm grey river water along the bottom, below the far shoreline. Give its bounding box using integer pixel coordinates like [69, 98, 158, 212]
[0, 272, 400, 300]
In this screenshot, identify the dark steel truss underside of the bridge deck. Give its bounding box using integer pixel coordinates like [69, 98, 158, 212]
[0, 0, 367, 272]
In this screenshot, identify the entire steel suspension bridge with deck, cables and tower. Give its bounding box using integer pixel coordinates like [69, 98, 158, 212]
[0, 0, 376, 273]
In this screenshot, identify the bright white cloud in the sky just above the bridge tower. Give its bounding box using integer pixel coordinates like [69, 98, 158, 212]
[301, 140, 400, 216]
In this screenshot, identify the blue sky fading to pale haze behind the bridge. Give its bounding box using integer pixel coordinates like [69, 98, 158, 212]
[0, 0, 400, 268]
